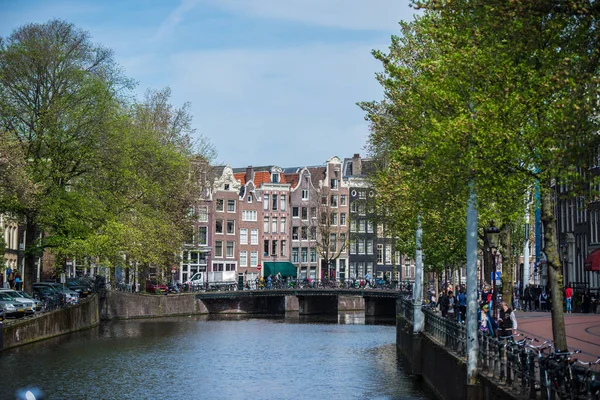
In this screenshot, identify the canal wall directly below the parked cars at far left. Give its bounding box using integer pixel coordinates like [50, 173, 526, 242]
[0, 295, 100, 350]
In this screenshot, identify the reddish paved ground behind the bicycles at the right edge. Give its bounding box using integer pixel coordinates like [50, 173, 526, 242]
[515, 311, 600, 361]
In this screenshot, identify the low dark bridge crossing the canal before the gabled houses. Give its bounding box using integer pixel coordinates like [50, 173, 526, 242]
[196, 289, 406, 317]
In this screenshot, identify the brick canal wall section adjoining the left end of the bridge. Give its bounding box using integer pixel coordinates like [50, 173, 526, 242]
[100, 291, 209, 320]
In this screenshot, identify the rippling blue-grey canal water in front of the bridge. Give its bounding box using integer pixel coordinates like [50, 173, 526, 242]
[0, 314, 430, 400]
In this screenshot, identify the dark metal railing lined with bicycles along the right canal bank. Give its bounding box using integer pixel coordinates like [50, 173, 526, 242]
[398, 300, 600, 400]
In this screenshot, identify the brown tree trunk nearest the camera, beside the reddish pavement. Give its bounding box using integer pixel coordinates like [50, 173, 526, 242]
[542, 187, 568, 351]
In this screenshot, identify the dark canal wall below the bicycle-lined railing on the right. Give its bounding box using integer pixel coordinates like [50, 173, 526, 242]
[396, 313, 522, 400]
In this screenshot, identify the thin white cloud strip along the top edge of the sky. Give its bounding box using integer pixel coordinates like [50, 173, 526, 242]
[202, 0, 414, 32]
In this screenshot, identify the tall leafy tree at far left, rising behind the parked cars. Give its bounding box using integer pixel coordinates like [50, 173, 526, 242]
[0, 20, 129, 290]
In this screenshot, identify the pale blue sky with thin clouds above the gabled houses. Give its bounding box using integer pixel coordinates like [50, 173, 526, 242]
[0, 0, 414, 168]
